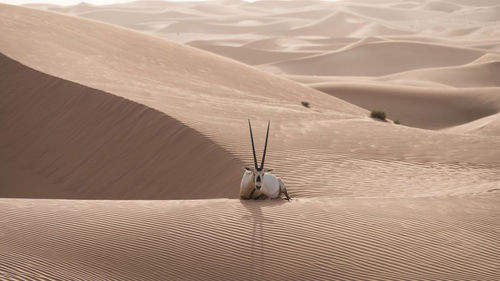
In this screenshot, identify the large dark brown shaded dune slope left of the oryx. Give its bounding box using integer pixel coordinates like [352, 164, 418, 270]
[0, 55, 241, 199]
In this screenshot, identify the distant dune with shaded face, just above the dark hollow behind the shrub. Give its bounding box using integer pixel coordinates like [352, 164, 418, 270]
[266, 42, 484, 76]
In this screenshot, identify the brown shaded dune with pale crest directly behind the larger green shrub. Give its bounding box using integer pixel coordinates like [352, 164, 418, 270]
[310, 82, 500, 129]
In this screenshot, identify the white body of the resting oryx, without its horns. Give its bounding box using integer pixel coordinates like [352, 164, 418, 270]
[240, 170, 286, 199]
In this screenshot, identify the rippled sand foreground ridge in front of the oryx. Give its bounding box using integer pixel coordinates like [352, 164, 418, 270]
[0, 197, 500, 280]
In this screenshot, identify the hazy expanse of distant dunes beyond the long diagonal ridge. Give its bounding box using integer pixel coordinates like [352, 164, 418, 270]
[33, 0, 500, 135]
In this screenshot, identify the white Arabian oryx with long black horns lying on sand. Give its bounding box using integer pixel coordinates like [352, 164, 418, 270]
[240, 120, 290, 200]
